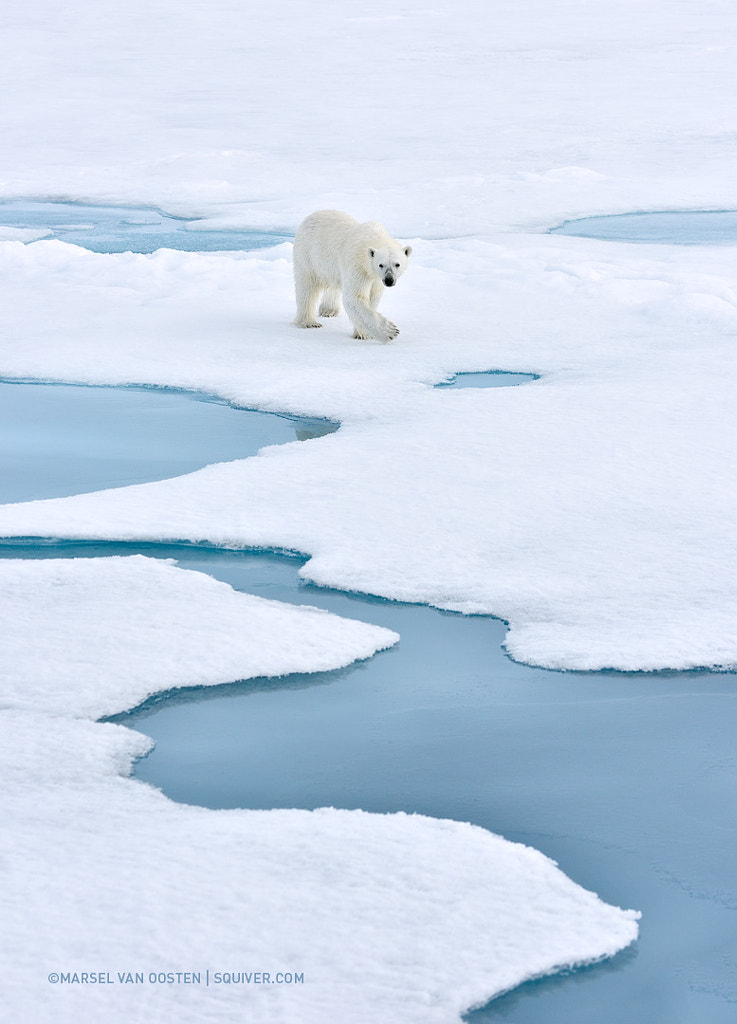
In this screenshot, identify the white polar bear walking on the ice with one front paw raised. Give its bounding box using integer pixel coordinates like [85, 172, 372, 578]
[294, 210, 411, 341]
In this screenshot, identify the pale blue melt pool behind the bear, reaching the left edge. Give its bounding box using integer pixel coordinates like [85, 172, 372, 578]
[0, 200, 292, 253]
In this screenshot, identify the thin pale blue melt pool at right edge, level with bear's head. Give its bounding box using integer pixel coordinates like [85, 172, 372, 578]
[550, 210, 737, 246]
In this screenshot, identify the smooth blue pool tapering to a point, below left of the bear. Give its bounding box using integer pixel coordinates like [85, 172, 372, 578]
[0, 382, 338, 502]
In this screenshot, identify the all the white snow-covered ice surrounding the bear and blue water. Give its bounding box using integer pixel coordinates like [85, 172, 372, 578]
[5, 0, 737, 1024]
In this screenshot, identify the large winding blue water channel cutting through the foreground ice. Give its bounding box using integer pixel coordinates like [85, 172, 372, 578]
[2, 385, 737, 1024]
